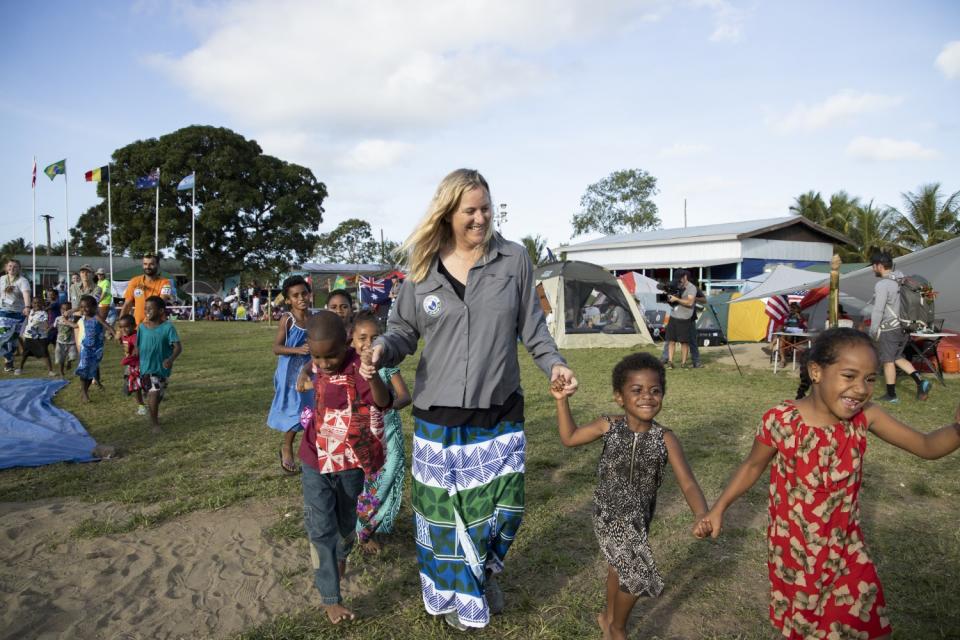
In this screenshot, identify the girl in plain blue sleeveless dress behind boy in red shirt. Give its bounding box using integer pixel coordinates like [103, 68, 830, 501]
[267, 276, 313, 475]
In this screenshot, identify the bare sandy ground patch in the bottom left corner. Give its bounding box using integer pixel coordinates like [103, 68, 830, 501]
[0, 500, 322, 639]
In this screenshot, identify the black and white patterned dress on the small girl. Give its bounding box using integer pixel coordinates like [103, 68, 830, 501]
[593, 416, 667, 596]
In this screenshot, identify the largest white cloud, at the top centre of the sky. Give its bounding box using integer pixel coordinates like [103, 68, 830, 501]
[148, 0, 659, 137]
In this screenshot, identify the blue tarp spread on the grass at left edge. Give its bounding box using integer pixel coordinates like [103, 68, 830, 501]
[0, 378, 97, 469]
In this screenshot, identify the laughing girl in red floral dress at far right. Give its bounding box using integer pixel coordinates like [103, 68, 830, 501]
[695, 328, 960, 640]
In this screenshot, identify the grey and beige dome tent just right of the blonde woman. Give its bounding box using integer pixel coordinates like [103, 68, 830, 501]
[533, 260, 653, 349]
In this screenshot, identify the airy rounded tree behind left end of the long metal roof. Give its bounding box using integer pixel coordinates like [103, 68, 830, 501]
[571, 169, 660, 236]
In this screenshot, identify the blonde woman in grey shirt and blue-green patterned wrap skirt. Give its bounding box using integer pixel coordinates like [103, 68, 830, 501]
[368, 169, 577, 630]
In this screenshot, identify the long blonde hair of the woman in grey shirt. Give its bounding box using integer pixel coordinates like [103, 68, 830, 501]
[398, 169, 493, 282]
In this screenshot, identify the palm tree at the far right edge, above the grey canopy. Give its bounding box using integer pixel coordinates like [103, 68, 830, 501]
[891, 182, 960, 251]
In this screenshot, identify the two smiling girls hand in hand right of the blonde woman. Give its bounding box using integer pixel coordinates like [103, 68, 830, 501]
[551, 328, 960, 640]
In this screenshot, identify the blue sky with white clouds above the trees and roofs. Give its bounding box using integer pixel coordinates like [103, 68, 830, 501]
[0, 0, 960, 255]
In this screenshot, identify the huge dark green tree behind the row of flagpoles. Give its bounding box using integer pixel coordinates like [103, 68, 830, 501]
[73, 126, 327, 280]
